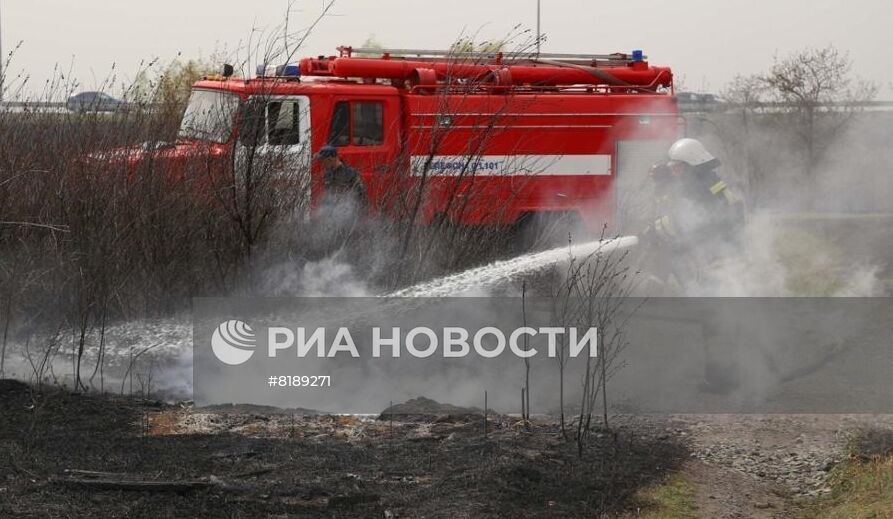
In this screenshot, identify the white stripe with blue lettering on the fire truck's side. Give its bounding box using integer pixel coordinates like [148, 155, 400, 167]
[411, 155, 611, 176]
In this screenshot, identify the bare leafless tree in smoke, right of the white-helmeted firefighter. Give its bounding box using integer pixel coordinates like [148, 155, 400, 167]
[714, 46, 878, 204]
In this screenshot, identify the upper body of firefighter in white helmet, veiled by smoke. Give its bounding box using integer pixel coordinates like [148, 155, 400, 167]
[646, 138, 744, 295]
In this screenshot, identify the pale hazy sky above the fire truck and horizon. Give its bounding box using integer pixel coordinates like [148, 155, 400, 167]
[0, 0, 893, 99]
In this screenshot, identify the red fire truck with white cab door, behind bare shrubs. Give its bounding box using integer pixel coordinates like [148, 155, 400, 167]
[171, 47, 681, 234]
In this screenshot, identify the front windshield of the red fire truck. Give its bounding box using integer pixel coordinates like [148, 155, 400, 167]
[177, 90, 239, 143]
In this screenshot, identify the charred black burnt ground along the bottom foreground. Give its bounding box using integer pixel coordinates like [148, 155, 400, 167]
[0, 381, 687, 518]
